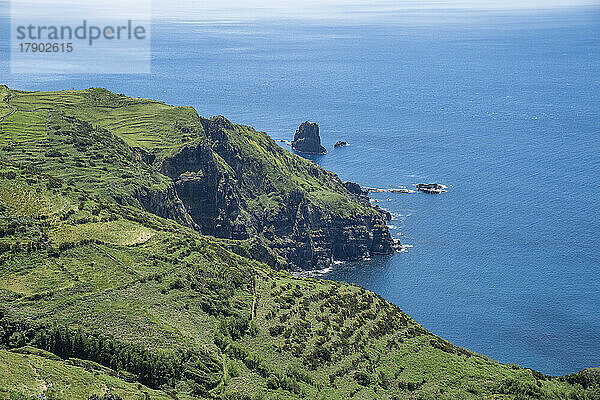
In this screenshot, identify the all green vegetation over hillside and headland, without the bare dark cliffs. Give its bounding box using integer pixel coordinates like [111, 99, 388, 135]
[0, 88, 600, 400]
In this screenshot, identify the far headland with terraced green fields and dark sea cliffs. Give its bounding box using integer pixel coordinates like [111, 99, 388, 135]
[0, 87, 394, 268]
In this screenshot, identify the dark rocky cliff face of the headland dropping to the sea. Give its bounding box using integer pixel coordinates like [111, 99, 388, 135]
[152, 117, 394, 269]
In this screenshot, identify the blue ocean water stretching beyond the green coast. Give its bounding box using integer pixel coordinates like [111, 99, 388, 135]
[0, 8, 600, 374]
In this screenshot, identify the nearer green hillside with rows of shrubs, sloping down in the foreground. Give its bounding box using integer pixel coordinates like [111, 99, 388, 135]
[0, 164, 597, 399]
